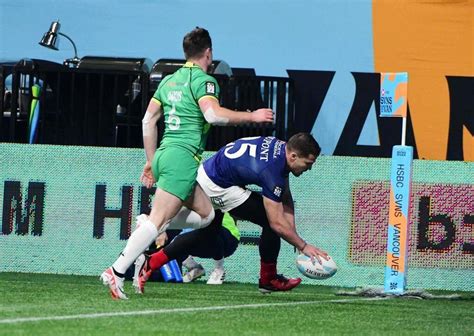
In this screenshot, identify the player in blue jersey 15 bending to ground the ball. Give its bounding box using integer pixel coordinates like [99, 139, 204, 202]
[139, 133, 328, 293]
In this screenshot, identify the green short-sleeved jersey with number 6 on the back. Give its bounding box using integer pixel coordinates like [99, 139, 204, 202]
[153, 62, 219, 154]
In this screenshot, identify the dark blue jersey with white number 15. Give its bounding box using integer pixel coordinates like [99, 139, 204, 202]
[203, 136, 289, 202]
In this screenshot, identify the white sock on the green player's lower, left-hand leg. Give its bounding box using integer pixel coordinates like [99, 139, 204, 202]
[112, 220, 158, 274]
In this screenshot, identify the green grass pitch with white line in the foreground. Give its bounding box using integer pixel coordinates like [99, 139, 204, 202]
[0, 273, 474, 336]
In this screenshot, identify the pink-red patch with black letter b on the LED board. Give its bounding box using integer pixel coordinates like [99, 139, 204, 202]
[350, 181, 474, 271]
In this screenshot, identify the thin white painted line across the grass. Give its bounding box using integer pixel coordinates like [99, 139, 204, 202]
[0, 297, 387, 324]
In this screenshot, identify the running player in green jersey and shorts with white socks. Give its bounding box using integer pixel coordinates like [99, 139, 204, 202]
[100, 27, 273, 299]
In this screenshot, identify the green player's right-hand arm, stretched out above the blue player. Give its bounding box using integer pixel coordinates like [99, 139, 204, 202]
[199, 97, 273, 126]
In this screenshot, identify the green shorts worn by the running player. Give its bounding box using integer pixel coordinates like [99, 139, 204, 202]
[151, 147, 200, 201]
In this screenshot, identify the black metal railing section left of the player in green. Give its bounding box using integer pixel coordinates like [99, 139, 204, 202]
[1, 61, 148, 147]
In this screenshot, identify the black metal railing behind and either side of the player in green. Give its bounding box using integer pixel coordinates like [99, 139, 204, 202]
[0, 60, 294, 150]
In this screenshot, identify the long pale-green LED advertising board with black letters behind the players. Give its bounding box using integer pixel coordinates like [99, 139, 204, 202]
[0, 143, 474, 291]
